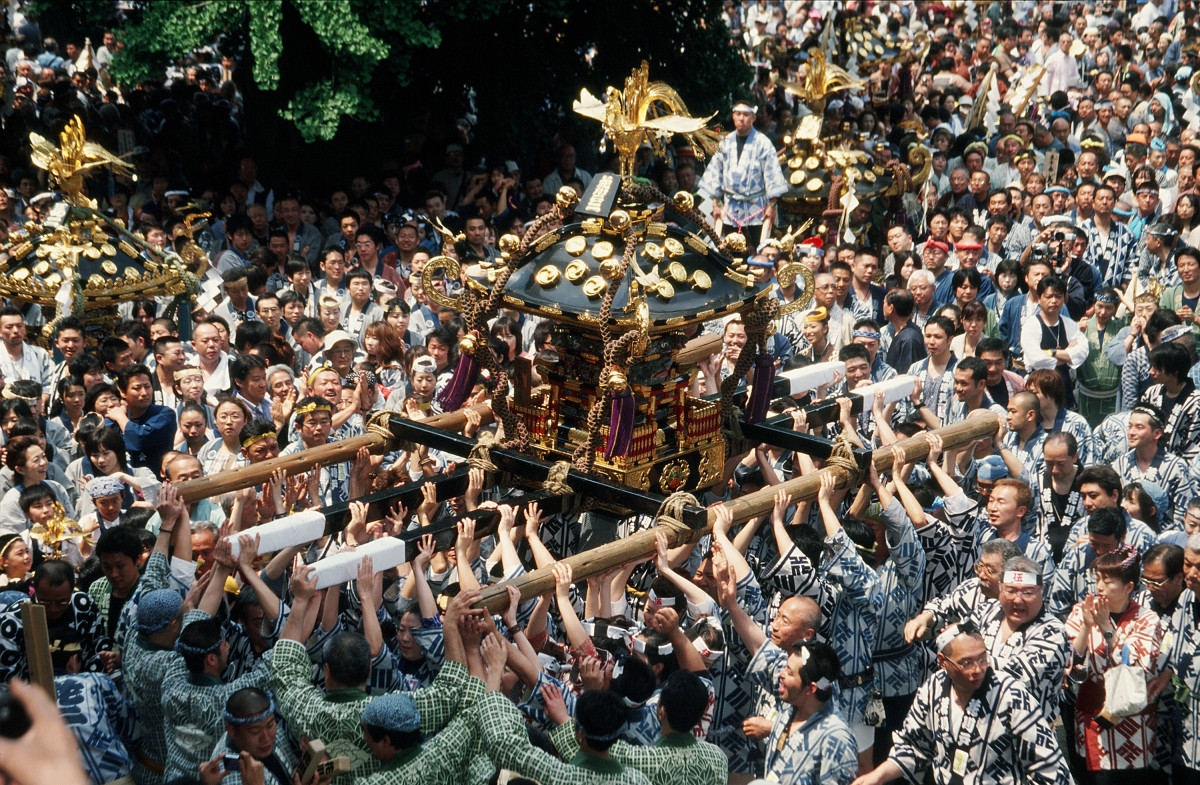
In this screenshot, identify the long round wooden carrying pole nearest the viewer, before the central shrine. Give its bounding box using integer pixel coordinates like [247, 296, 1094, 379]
[480, 412, 998, 613]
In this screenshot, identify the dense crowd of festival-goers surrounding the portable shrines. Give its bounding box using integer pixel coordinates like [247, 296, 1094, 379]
[9, 0, 1200, 785]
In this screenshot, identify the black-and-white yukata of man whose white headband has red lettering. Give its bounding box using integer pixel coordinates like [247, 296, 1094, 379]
[972, 600, 1070, 725]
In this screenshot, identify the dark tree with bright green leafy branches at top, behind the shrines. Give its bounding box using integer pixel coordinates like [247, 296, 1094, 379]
[49, 0, 750, 157]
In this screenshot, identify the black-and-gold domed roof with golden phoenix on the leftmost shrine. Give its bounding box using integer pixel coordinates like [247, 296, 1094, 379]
[0, 116, 206, 337]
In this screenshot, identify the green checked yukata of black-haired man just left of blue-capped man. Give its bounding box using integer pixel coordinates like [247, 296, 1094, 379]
[272, 639, 478, 785]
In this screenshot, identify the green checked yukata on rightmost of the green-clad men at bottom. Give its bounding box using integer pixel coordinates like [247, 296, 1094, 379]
[550, 723, 730, 785]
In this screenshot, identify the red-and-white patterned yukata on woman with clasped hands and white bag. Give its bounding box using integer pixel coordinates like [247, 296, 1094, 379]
[1067, 600, 1163, 772]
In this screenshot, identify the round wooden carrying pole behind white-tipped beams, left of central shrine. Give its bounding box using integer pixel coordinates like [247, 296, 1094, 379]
[172, 403, 494, 504]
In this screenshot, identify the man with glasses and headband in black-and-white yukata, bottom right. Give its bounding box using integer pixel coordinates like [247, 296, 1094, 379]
[854, 622, 1073, 785]
